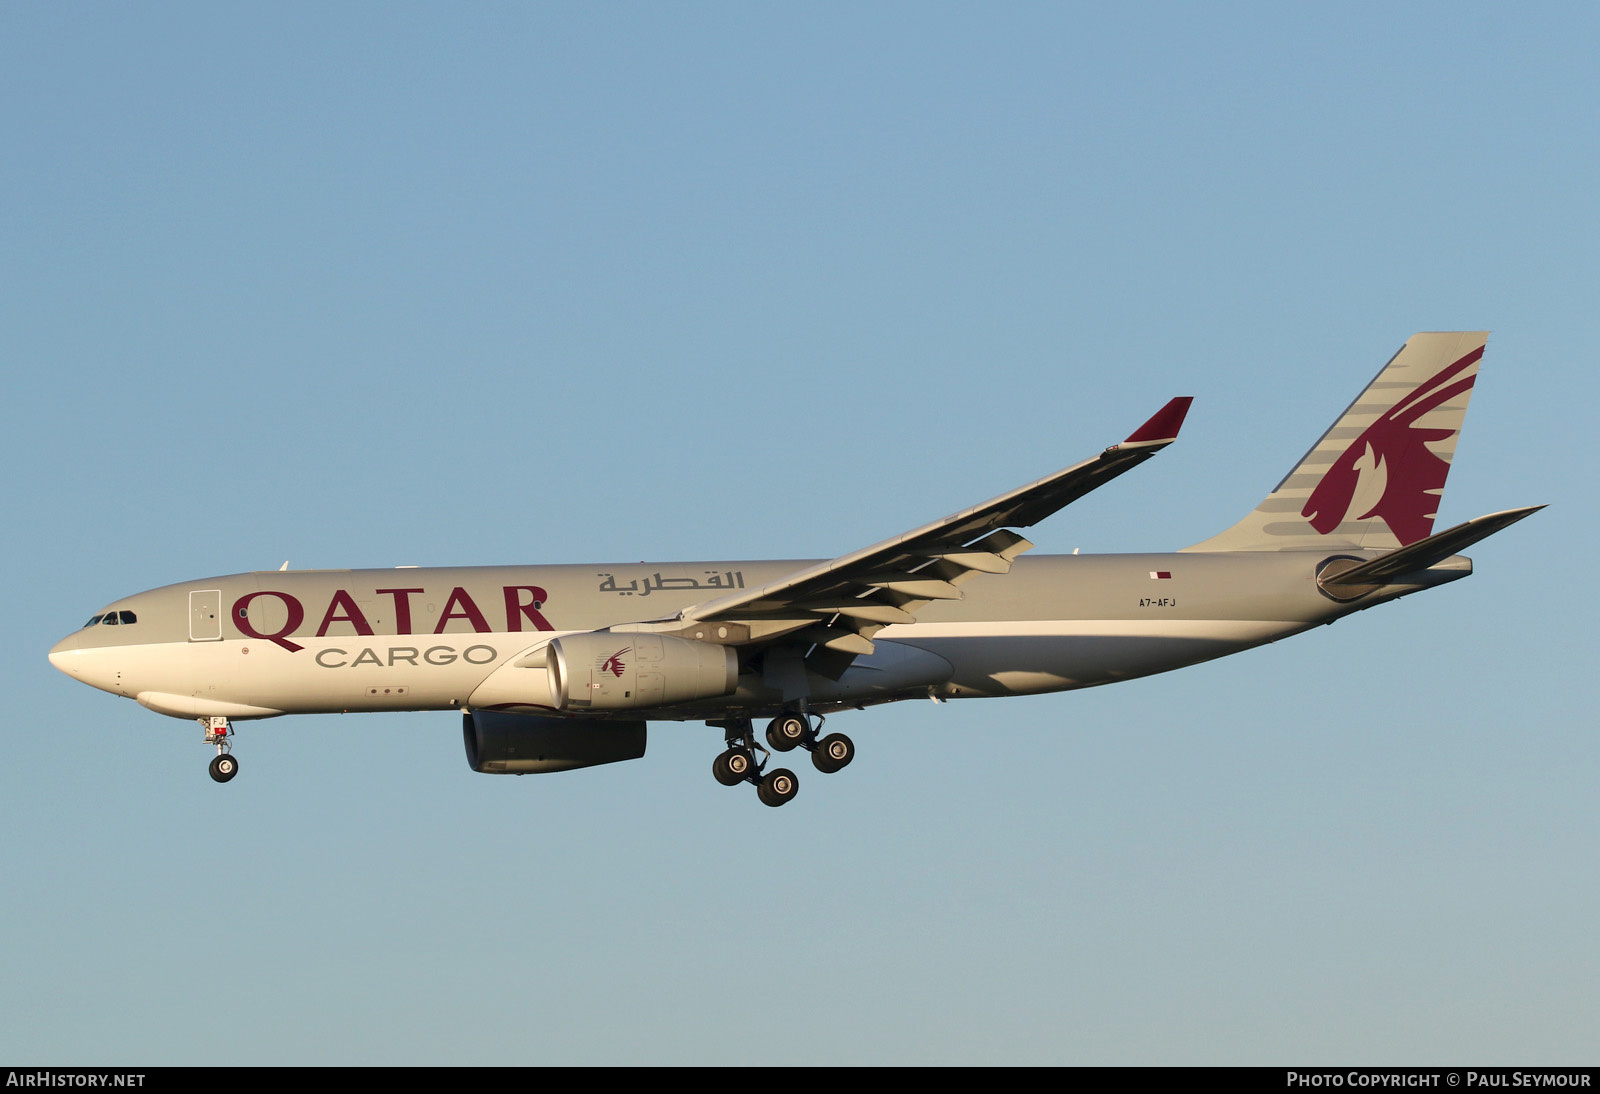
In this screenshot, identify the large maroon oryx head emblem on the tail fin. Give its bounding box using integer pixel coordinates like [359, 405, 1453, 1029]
[1301, 345, 1483, 544]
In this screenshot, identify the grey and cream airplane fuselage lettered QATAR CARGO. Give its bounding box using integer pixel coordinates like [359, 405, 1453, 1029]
[50, 552, 1470, 720]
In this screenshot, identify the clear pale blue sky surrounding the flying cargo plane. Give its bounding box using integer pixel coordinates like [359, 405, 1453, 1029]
[0, 0, 1600, 1064]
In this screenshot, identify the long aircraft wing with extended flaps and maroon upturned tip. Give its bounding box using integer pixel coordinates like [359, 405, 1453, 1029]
[656, 397, 1192, 680]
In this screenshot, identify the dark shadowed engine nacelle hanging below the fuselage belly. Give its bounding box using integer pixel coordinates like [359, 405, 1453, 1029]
[461, 710, 645, 774]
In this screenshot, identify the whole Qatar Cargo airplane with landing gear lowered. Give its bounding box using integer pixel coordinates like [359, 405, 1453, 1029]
[50, 331, 1542, 806]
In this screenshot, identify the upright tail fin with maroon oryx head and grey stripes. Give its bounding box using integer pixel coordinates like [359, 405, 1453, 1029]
[1184, 331, 1488, 550]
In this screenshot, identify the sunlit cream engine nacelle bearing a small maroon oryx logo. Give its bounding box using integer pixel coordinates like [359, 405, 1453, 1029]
[546, 630, 739, 710]
